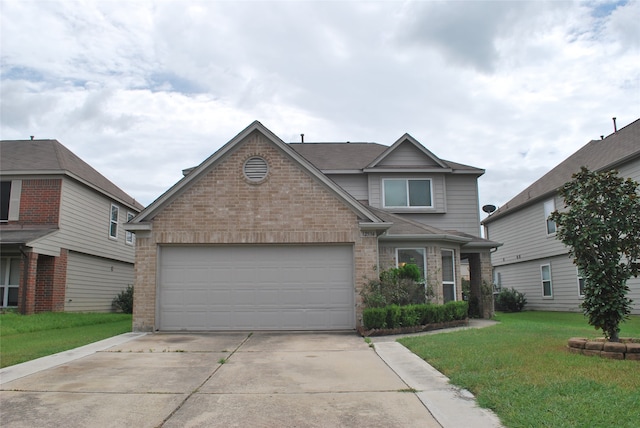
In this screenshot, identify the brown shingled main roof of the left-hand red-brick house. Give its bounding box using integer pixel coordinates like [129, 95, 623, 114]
[0, 140, 144, 211]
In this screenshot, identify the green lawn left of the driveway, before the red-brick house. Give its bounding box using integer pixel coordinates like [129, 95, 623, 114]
[0, 312, 131, 367]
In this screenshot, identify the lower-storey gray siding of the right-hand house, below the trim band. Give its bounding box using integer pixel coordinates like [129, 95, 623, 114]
[494, 255, 640, 315]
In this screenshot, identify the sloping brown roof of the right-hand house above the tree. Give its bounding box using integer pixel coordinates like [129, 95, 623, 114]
[482, 119, 640, 224]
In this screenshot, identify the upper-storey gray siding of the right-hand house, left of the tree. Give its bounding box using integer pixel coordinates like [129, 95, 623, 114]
[487, 197, 567, 266]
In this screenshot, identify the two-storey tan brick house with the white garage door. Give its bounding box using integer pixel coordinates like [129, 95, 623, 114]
[126, 121, 498, 331]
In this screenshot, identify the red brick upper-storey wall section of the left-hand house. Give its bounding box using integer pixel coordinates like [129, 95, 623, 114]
[19, 179, 62, 225]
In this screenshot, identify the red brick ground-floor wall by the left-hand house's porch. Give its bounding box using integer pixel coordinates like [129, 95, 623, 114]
[35, 249, 68, 312]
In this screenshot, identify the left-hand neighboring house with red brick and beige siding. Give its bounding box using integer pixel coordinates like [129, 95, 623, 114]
[0, 140, 143, 314]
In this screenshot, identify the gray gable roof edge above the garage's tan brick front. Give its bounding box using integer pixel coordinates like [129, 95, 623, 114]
[128, 120, 390, 230]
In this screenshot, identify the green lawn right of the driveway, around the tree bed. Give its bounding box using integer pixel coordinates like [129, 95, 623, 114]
[400, 312, 640, 427]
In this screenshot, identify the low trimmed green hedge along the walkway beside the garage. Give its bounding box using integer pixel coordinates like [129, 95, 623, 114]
[362, 301, 469, 329]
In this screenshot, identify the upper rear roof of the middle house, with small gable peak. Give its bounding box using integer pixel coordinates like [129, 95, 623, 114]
[289, 134, 484, 175]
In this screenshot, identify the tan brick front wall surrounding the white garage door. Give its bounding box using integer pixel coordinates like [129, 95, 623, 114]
[134, 132, 377, 331]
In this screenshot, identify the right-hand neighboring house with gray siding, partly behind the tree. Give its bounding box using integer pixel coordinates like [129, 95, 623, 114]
[483, 119, 640, 314]
